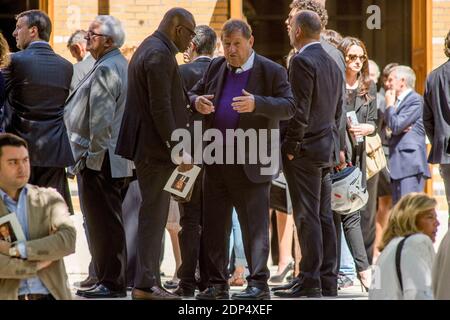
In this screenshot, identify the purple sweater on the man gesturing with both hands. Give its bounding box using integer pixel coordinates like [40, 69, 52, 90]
[214, 69, 251, 137]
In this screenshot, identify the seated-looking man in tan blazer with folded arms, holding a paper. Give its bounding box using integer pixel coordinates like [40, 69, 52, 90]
[0, 133, 76, 300]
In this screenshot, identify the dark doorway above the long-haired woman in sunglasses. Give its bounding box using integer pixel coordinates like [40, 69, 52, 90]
[326, 0, 412, 74]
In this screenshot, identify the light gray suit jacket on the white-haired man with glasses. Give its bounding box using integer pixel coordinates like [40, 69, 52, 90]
[64, 49, 133, 178]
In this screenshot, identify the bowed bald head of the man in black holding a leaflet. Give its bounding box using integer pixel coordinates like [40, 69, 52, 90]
[158, 8, 195, 52]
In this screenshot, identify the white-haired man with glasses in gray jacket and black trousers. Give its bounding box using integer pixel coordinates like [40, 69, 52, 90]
[64, 15, 132, 298]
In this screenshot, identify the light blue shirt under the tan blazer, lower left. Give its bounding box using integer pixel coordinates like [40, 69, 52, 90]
[0, 186, 50, 296]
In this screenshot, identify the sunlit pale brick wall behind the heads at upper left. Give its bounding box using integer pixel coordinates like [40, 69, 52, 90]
[53, 0, 229, 61]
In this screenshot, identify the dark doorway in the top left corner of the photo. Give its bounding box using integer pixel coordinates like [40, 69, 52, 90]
[0, 0, 39, 52]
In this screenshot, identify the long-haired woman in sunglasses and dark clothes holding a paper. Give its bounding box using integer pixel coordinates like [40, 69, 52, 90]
[334, 37, 377, 291]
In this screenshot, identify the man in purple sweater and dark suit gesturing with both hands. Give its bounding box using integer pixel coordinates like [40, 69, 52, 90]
[189, 20, 295, 300]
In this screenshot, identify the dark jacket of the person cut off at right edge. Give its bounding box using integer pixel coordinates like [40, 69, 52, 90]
[423, 60, 450, 164]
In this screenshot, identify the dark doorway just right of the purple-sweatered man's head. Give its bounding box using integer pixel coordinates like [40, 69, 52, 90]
[243, 0, 292, 65]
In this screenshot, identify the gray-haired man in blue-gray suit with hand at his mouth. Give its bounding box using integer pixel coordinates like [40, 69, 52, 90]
[384, 66, 430, 205]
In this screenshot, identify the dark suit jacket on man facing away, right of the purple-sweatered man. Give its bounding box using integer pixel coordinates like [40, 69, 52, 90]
[283, 44, 343, 167]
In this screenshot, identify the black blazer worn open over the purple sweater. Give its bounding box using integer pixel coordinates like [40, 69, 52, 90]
[189, 54, 295, 183]
